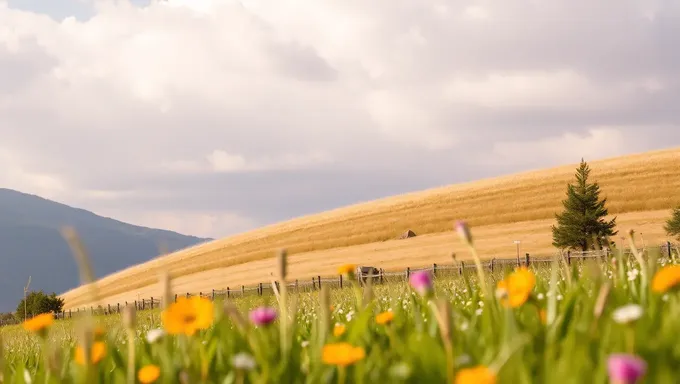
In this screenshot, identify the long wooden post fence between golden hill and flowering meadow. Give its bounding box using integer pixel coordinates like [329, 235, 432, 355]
[0, 242, 678, 326]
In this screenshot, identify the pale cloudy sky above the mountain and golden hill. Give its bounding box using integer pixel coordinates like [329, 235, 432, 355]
[0, 0, 680, 238]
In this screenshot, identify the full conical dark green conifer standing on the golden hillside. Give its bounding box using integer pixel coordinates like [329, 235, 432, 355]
[552, 159, 618, 251]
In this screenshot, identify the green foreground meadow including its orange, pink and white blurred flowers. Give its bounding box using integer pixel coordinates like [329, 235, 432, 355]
[0, 223, 680, 384]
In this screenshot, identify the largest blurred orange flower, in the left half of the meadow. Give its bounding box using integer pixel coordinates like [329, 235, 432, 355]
[161, 296, 214, 336]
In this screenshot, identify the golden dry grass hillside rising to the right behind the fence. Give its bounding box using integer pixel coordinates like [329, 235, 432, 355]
[62, 148, 680, 309]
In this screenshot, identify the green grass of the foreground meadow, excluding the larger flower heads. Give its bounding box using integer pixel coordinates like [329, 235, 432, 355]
[0, 236, 680, 384]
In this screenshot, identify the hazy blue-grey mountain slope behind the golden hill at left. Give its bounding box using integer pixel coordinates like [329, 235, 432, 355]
[0, 188, 212, 312]
